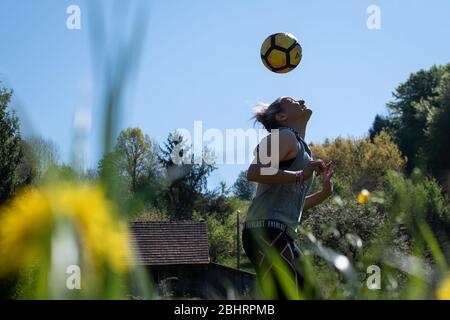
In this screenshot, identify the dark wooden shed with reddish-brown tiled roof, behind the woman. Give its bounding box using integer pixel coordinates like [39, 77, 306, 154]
[130, 221, 255, 299]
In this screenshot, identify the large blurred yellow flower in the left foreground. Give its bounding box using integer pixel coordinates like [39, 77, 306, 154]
[0, 183, 130, 276]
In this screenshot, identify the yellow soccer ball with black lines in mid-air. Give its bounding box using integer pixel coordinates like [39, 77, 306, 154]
[261, 33, 302, 73]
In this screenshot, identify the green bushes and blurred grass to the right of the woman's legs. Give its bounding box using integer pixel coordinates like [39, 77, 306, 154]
[299, 170, 450, 299]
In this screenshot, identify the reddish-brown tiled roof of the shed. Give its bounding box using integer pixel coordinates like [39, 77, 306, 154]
[130, 221, 209, 266]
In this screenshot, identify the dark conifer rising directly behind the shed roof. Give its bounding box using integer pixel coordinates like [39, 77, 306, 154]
[159, 132, 215, 219]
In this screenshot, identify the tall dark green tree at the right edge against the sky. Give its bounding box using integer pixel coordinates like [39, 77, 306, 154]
[370, 64, 450, 172]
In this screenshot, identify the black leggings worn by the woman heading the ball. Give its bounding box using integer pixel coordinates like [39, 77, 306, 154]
[242, 227, 303, 300]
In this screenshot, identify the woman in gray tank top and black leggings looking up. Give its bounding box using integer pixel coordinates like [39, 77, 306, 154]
[242, 97, 333, 299]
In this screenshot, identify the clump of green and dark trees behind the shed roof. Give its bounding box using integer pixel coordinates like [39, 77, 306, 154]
[99, 128, 236, 220]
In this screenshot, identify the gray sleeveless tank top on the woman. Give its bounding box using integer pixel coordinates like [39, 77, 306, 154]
[245, 128, 314, 239]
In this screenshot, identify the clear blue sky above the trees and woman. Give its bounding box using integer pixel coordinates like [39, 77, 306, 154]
[0, 0, 450, 187]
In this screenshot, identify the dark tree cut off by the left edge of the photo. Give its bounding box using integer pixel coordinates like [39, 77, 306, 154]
[0, 87, 22, 204]
